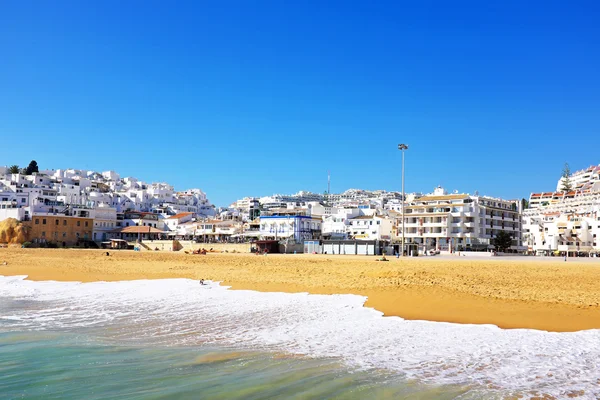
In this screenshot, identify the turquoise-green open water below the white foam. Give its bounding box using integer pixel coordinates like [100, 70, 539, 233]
[0, 332, 466, 399]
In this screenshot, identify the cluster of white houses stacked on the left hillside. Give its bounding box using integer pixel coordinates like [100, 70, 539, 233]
[0, 168, 214, 241]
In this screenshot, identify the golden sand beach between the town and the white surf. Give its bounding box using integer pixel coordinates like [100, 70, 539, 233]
[0, 248, 600, 331]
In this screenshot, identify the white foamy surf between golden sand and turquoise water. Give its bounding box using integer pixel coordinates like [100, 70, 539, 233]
[0, 276, 600, 398]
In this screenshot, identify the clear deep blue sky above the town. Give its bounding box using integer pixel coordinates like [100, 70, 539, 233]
[0, 0, 600, 205]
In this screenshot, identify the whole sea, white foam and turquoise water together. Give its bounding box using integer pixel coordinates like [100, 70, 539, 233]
[0, 276, 600, 399]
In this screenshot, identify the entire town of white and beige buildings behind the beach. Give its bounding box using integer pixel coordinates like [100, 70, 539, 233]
[0, 161, 600, 256]
